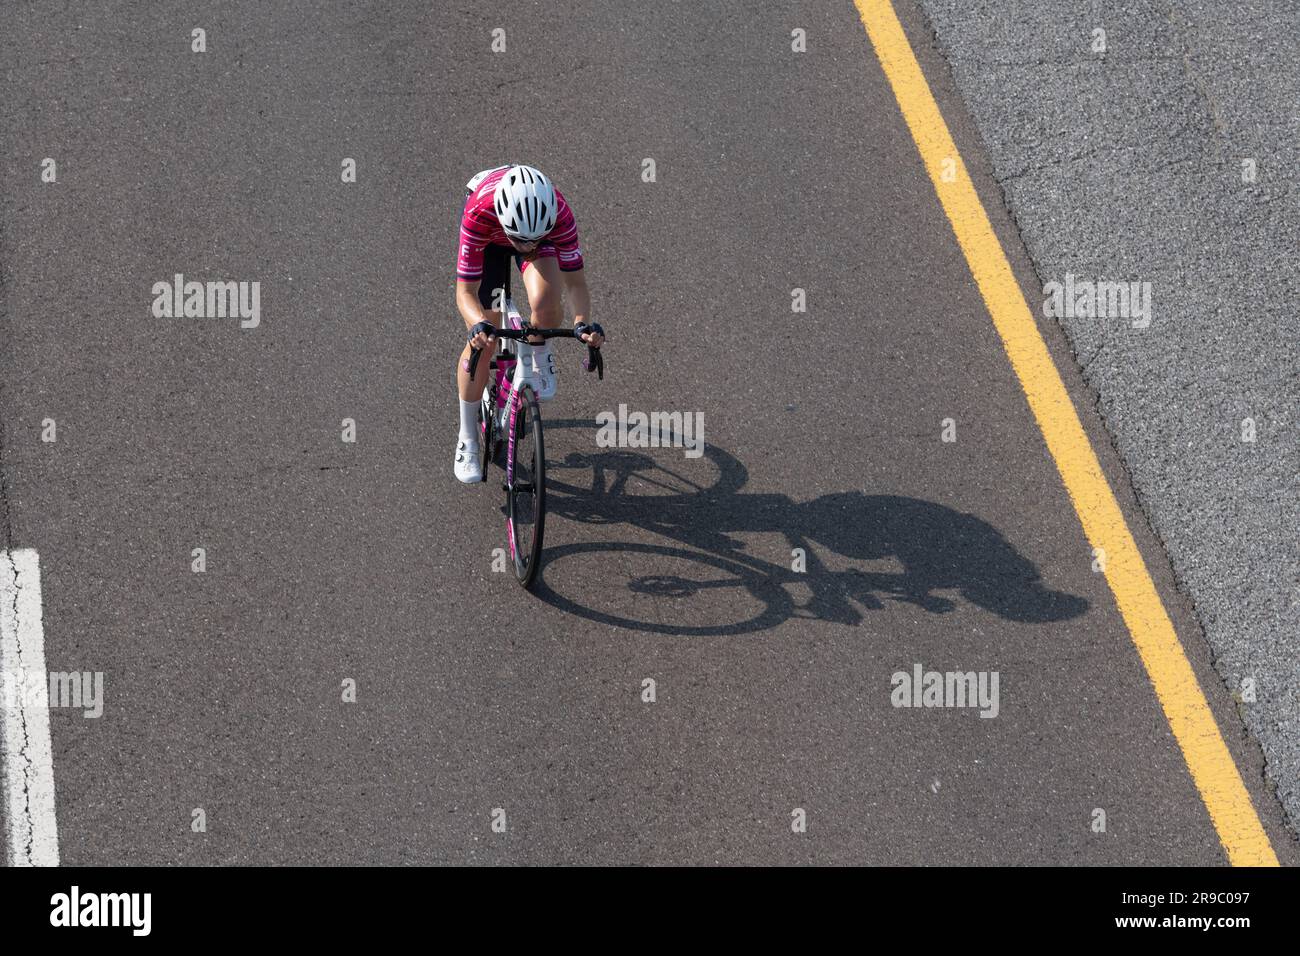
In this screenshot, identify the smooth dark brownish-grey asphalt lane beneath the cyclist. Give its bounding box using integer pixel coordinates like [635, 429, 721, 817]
[0, 3, 1296, 865]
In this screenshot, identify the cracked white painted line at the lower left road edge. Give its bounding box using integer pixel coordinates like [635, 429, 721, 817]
[0, 548, 59, 866]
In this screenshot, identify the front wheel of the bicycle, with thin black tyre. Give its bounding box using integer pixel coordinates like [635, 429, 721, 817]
[506, 386, 546, 588]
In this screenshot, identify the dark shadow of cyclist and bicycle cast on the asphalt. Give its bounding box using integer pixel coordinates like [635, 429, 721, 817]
[534, 420, 1088, 635]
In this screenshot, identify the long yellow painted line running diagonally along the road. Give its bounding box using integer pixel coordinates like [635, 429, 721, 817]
[854, 0, 1278, 866]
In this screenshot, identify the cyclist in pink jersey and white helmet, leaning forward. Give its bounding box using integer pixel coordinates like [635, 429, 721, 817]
[455, 165, 605, 484]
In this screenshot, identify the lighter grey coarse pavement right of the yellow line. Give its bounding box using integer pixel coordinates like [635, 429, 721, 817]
[924, 0, 1300, 826]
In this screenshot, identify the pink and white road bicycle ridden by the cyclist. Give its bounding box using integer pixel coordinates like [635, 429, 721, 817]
[468, 306, 605, 588]
